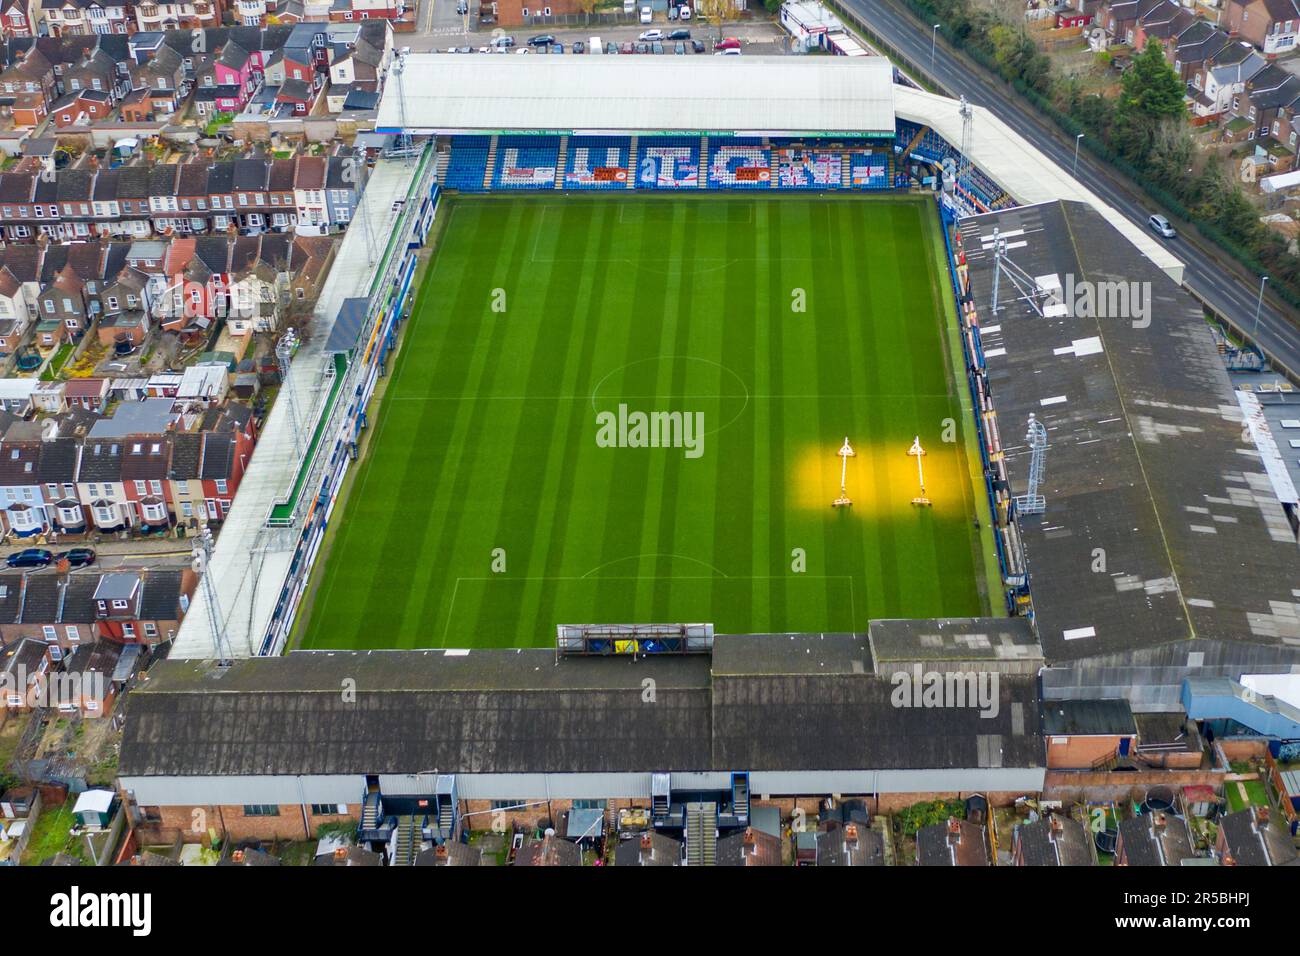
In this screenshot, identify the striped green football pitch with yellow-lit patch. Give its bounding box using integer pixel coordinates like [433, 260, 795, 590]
[300, 195, 988, 648]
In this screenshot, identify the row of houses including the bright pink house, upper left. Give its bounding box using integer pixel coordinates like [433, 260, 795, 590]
[0, 21, 393, 129]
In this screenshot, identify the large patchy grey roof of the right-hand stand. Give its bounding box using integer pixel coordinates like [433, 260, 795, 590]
[961, 202, 1300, 661]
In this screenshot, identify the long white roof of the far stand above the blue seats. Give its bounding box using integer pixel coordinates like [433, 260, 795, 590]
[376, 53, 894, 137]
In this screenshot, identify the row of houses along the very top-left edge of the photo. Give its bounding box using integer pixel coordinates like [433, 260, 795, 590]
[0, 0, 410, 36]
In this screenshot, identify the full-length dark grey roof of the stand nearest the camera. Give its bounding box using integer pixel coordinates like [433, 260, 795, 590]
[121, 635, 1044, 775]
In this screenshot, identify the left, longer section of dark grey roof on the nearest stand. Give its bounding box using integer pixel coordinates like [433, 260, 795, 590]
[121, 650, 710, 775]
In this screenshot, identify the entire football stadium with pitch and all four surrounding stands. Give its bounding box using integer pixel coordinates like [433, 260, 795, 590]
[120, 48, 1300, 848]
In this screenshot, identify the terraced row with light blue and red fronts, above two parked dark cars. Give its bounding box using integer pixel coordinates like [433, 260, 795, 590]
[0, 395, 257, 540]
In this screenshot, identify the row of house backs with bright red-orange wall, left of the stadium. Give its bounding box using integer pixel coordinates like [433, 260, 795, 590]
[0, 233, 334, 355]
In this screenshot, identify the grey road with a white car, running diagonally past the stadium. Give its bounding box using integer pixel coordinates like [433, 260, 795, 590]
[840, 0, 1300, 375]
